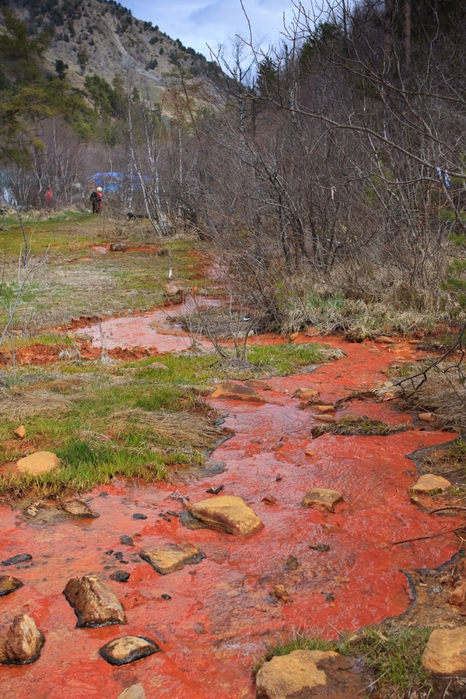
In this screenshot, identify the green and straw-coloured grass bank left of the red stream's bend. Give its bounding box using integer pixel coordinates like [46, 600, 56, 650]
[0, 344, 334, 495]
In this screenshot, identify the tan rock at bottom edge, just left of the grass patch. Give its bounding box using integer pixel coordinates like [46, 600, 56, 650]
[256, 650, 338, 699]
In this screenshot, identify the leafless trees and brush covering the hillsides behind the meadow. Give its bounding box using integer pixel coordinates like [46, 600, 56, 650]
[0, 0, 466, 338]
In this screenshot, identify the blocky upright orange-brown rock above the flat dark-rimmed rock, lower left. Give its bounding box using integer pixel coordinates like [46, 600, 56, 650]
[63, 575, 126, 627]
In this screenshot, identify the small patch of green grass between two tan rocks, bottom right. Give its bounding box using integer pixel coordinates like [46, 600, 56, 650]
[256, 626, 432, 699]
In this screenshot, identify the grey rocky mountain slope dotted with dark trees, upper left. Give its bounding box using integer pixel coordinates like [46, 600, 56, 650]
[4, 0, 221, 96]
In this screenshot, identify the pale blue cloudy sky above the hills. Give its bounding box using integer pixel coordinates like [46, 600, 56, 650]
[124, 0, 302, 58]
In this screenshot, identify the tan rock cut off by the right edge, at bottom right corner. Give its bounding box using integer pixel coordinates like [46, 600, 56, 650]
[422, 626, 466, 675]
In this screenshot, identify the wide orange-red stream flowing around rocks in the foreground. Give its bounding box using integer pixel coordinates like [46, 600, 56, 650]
[0, 330, 459, 699]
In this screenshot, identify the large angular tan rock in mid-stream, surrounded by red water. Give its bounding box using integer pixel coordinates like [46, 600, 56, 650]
[188, 495, 264, 539]
